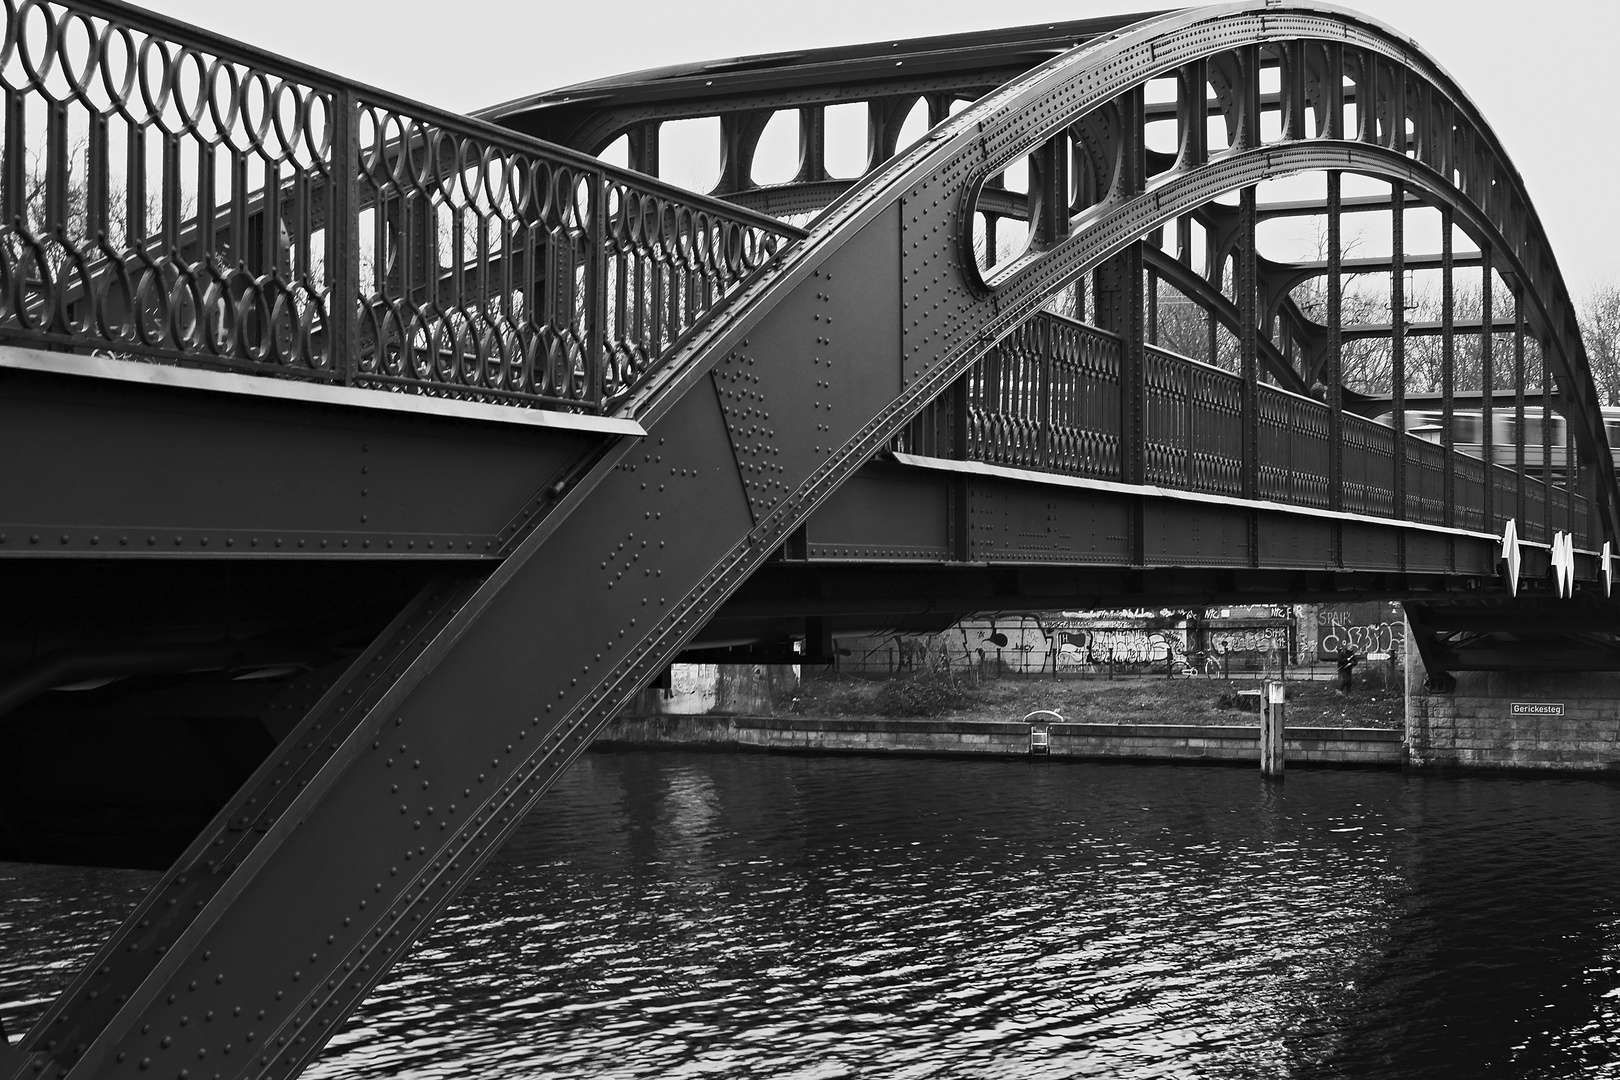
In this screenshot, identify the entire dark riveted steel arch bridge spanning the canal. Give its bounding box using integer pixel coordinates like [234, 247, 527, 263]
[0, 0, 1620, 1077]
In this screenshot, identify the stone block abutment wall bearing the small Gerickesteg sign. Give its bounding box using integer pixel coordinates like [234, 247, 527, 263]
[1406, 662, 1620, 771]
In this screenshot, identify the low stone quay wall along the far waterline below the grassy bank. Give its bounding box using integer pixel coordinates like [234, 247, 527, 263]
[596, 716, 1403, 766]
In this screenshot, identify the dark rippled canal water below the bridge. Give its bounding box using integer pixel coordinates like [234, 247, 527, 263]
[0, 753, 1620, 1080]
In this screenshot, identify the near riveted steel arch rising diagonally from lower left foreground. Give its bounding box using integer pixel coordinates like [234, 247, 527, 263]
[19, 3, 1615, 1077]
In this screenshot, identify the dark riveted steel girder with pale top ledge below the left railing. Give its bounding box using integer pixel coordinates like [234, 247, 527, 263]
[0, 347, 642, 559]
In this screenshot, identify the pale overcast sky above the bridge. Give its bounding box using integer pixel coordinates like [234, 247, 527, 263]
[147, 0, 1620, 296]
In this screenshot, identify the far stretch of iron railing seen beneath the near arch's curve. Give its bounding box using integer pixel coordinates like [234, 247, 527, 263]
[894, 314, 1597, 547]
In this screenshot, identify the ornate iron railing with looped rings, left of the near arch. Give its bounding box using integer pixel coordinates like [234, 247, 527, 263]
[0, 0, 799, 411]
